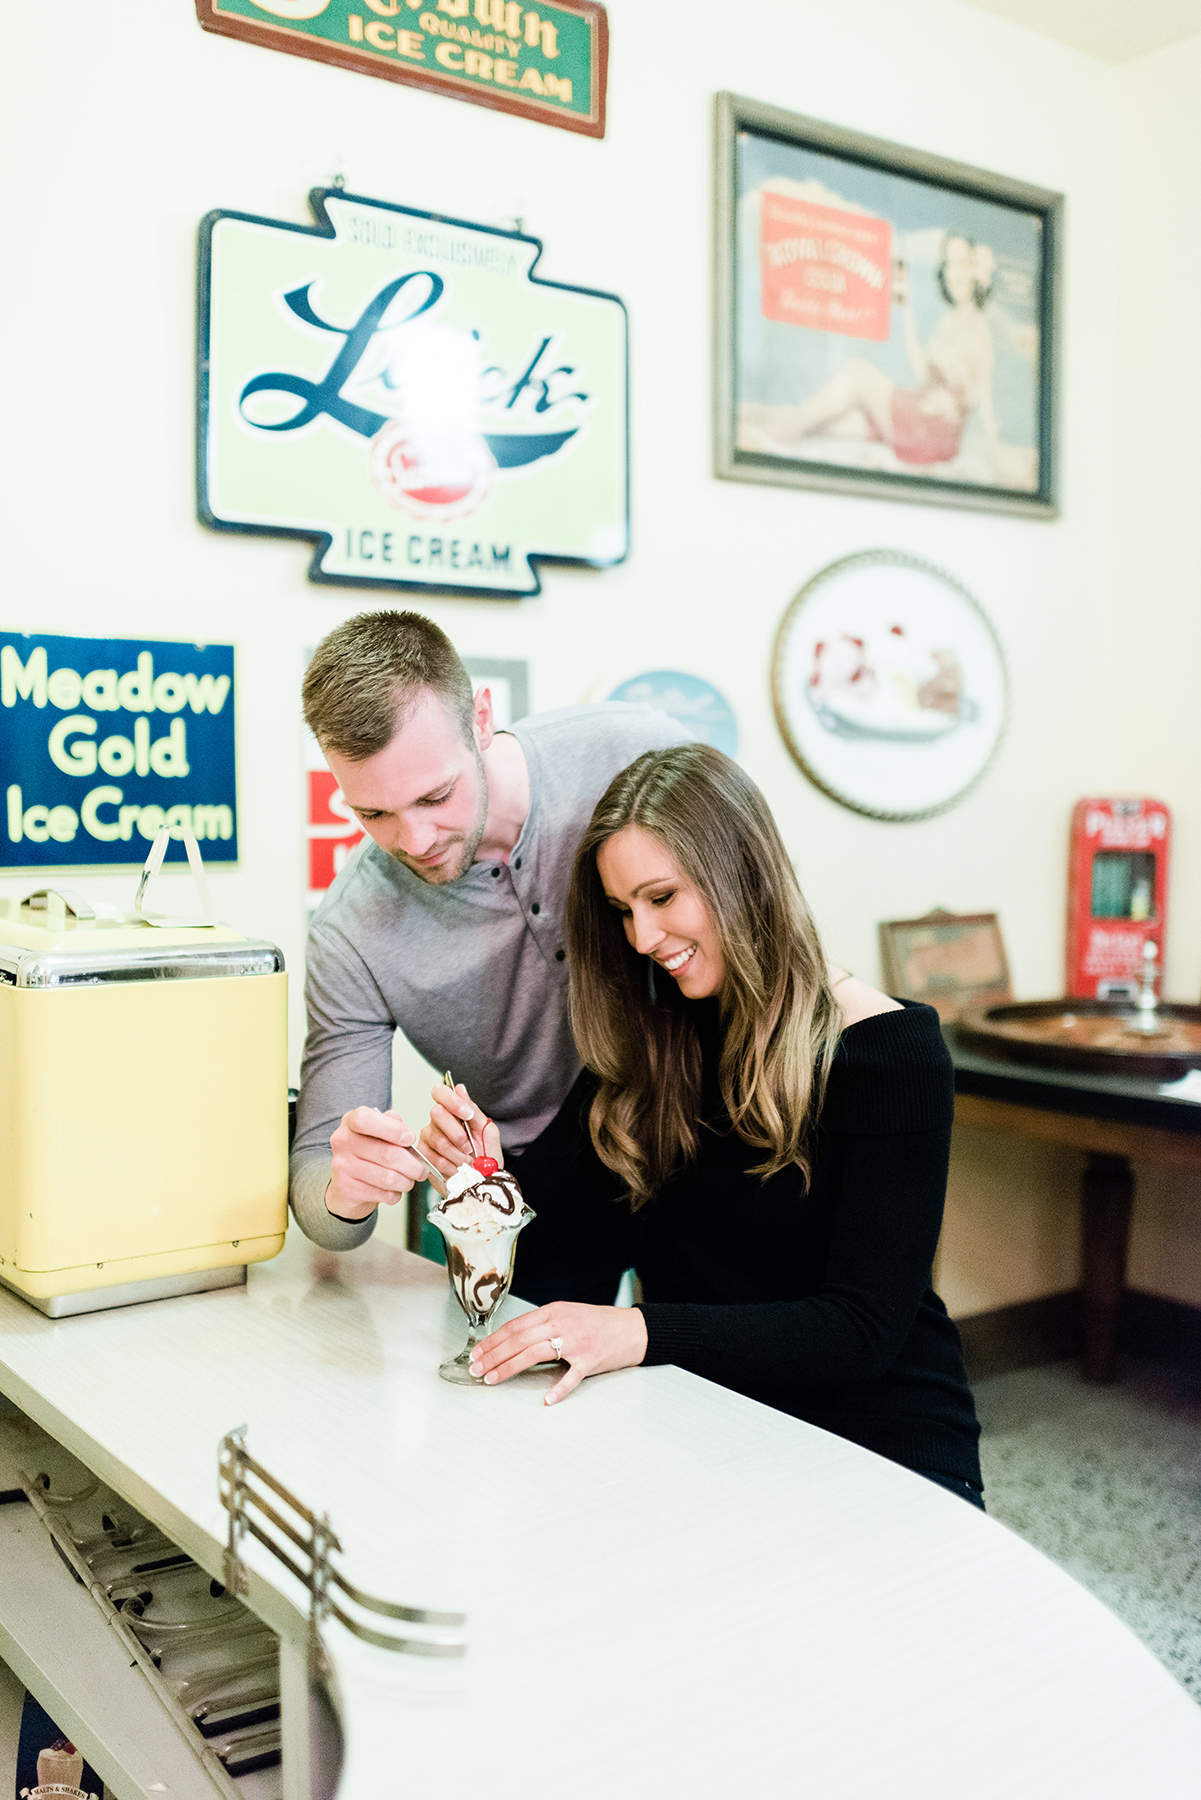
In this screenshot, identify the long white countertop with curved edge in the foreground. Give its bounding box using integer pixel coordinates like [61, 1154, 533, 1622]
[0, 1231, 1201, 1800]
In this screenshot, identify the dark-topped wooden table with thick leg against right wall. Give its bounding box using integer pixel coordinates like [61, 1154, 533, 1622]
[944, 1026, 1201, 1381]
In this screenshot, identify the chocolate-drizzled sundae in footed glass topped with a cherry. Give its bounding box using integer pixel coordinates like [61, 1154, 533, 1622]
[429, 1156, 535, 1386]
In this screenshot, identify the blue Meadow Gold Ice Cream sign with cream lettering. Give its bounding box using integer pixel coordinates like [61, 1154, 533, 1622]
[0, 632, 238, 868]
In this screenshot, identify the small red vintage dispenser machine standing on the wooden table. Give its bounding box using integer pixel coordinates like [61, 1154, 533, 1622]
[1066, 799, 1172, 1001]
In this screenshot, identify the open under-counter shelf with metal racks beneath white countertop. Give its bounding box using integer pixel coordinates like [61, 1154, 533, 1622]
[0, 1402, 283, 1800]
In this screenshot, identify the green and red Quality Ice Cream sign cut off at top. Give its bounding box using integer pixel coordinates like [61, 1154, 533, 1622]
[196, 0, 609, 137]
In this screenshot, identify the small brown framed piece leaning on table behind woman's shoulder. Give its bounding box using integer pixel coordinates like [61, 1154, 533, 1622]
[880, 911, 1014, 1022]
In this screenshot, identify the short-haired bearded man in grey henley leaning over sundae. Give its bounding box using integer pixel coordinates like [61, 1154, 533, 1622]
[292, 612, 688, 1249]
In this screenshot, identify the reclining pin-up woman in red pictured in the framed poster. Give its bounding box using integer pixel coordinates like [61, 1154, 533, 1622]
[789, 234, 1001, 466]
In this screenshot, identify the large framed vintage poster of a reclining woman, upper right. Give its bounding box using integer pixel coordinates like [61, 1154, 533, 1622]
[715, 94, 1062, 518]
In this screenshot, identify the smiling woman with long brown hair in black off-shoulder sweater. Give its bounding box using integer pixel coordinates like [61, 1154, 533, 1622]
[427, 743, 983, 1505]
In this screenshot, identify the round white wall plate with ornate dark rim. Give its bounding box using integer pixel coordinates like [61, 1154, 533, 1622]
[772, 551, 1008, 819]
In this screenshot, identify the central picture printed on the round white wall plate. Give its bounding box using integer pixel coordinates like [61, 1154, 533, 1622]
[807, 625, 978, 743]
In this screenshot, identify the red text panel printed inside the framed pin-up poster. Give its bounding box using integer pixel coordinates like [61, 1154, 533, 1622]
[760, 193, 893, 342]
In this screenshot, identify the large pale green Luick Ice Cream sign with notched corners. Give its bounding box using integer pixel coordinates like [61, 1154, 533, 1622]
[198, 187, 628, 596]
